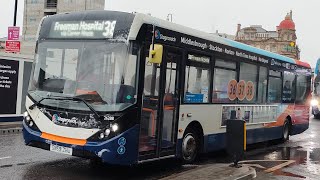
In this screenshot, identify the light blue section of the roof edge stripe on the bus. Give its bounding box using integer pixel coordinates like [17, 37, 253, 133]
[225, 39, 296, 64]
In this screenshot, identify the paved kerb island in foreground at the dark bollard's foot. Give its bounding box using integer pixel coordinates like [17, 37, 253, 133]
[162, 163, 256, 180]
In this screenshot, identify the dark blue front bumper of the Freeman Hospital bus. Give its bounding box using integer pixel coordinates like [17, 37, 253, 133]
[23, 121, 139, 165]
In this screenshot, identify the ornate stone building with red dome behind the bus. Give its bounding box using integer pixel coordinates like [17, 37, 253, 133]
[235, 11, 300, 59]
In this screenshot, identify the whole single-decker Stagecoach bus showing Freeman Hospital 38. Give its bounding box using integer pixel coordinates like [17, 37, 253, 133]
[23, 11, 311, 165]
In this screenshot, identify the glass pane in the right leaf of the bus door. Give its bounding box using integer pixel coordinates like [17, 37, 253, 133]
[161, 53, 177, 148]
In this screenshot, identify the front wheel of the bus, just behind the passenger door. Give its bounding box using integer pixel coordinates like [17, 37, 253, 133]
[181, 128, 200, 164]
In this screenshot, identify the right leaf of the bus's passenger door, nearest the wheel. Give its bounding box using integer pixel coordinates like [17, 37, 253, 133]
[159, 48, 182, 157]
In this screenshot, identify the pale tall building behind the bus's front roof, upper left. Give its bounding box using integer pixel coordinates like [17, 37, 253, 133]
[21, 0, 105, 54]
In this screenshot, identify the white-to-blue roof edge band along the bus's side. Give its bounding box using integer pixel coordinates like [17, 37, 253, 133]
[129, 13, 310, 68]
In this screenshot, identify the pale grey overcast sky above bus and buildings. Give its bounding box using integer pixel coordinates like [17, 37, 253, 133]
[0, 0, 320, 66]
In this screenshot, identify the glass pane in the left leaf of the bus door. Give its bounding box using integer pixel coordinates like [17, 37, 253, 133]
[139, 60, 160, 152]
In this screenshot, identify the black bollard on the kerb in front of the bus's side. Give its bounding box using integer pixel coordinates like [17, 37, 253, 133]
[226, 119, 247, 168]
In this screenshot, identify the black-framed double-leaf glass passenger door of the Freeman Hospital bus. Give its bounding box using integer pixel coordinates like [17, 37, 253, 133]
[139, 46, 182, 161]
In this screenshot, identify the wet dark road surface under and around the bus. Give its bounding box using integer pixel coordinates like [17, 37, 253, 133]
[0, 118, 320, 179]
